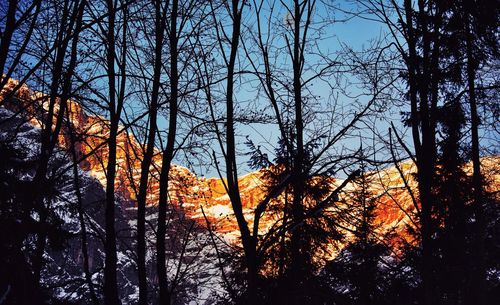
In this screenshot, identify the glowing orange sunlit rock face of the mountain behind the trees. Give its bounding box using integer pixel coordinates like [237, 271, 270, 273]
[0, 81, 500, 274]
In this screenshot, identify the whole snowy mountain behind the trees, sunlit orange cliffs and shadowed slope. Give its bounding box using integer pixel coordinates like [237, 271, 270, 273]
[0, 80, 500, 304]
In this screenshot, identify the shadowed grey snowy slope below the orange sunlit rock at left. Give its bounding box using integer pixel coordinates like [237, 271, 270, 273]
[0, 106, 230, 305]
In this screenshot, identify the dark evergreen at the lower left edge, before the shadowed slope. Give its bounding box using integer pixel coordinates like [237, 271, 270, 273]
[0, 136, 70, 305]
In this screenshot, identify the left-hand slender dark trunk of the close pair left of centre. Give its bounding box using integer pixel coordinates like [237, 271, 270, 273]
[137, 0, 165, 305]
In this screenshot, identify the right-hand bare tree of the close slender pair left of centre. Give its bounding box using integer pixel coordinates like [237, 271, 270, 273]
[156, 0, 206, 304]
